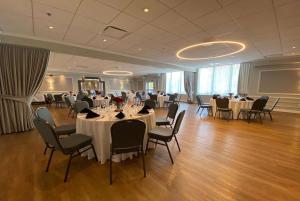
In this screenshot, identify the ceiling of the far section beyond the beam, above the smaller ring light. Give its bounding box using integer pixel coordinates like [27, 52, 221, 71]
[47, 52, 174, 76]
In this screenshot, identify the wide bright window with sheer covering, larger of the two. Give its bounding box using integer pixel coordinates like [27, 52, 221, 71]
[198, 64, 240, 95]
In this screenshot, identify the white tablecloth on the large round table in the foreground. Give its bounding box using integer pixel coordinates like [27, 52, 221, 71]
[76, 107, 155, 164]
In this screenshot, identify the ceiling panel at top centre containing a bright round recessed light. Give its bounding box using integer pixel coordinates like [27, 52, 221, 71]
[124, 0, 168, 22]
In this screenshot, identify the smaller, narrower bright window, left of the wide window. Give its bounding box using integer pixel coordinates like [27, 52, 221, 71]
[166, 71, 185, 94]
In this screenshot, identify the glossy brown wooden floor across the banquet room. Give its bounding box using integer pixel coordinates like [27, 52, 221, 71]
[0, 104, 300, 201]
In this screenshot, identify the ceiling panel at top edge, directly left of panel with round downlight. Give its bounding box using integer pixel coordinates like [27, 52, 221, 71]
[78, 0, 120, 23]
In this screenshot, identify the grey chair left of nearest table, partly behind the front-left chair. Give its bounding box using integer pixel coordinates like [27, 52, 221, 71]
[35, 107, 76, 155]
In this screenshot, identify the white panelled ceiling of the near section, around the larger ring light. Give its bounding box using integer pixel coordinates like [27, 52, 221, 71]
[0, 0, 300, 73]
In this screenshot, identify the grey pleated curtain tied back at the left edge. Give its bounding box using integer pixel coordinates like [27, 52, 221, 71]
[0, 44, 50, 134]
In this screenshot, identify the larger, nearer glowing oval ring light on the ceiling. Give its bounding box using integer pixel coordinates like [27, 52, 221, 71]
[176, 41, 246, 61]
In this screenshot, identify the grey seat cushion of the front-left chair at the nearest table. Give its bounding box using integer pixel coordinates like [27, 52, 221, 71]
[59, 134, 92, 154]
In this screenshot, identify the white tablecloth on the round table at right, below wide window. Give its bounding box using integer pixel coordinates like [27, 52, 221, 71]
[210, 98, 254, 119]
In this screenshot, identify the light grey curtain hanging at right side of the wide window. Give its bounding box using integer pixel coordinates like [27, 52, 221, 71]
[238, 63, 251, 94]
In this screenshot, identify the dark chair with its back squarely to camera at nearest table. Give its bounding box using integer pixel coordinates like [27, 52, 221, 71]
[109, 119, 146, 184]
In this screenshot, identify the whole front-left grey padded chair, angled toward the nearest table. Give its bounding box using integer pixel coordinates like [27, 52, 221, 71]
[33, 118, 98, 182]
